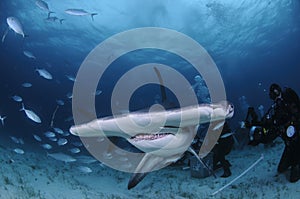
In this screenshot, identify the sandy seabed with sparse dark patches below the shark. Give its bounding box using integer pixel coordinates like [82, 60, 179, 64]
[0, 137, 300, 199]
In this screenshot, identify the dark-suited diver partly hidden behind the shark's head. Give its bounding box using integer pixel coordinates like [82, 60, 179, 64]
[212, 121, 234, 178]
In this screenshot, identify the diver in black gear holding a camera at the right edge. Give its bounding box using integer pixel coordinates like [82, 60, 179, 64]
[246, 84, 300, 182]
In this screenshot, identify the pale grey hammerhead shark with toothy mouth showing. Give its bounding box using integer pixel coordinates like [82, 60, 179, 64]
[70, 67, 234, 189]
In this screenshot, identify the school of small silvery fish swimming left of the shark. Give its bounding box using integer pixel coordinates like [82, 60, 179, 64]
[0, 0, 102, 174]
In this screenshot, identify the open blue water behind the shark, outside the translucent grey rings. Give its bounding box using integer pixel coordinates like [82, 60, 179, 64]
[0, 0, 300, 196]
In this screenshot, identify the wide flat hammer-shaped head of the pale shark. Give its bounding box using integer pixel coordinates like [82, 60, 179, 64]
[70, 101, 234, 139]
